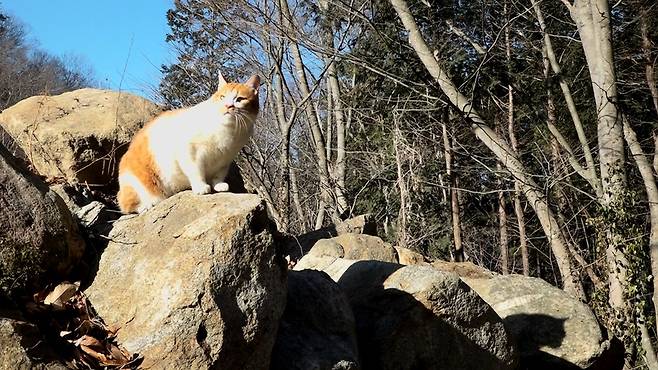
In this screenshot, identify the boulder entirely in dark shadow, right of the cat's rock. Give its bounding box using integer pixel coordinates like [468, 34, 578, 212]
[270, 270, 360, 370]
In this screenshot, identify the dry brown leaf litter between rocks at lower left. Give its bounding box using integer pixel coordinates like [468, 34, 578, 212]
[26, 282, 143, 369]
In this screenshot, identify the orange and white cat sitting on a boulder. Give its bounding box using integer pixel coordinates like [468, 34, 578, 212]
[117, 74, 260, 213]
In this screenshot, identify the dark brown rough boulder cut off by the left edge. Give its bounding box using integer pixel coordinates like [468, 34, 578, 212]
[0, 146, 85, 296]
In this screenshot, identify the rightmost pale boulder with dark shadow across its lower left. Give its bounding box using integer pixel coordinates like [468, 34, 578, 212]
[463, 275, 623, 369]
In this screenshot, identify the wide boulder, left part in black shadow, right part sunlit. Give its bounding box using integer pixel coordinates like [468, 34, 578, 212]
[295, 255, 517, 370]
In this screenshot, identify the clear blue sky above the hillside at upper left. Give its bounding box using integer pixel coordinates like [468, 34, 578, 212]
[0, 0, 174, 97]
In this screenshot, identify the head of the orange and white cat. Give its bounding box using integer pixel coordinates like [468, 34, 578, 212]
[211, 73, 260, 123]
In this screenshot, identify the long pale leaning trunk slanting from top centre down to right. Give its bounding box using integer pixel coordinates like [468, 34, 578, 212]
[389, 0, 584, 299]
